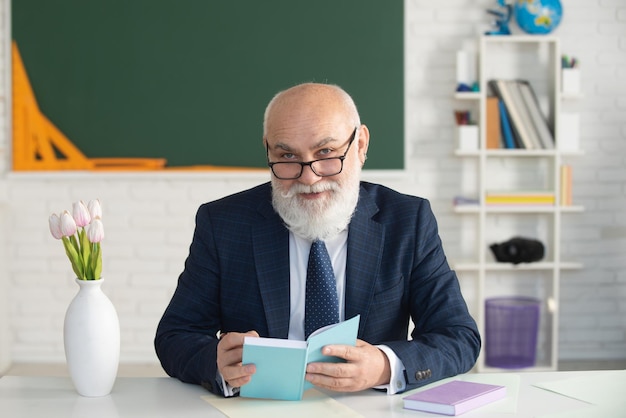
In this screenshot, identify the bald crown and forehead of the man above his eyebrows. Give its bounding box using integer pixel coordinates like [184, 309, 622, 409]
[263, 83, 361, 138]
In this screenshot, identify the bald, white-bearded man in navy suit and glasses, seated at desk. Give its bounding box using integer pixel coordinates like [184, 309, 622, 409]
[155, 83, 480, 396]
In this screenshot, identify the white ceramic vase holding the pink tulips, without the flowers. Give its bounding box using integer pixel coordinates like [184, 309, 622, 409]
[63, 279, 120, 397]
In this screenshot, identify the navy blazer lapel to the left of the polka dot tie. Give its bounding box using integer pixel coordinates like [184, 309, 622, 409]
[252, 194, 290, 338]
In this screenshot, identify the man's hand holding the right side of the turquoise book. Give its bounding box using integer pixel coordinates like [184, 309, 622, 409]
[306, 340, 391, 392]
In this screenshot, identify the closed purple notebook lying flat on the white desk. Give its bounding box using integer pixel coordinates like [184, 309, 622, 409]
[403, 380, 506, 415]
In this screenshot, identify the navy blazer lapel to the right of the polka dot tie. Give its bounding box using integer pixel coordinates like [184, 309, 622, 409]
[345, 188, 385, 335]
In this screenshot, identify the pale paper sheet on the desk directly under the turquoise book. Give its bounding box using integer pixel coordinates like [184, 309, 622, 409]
[201, 389, 362, 418]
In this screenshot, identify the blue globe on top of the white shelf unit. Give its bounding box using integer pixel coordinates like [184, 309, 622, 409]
[515, 0, 563, 35]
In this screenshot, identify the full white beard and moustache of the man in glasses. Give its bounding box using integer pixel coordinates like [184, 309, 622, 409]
[272, 179, 359, 241]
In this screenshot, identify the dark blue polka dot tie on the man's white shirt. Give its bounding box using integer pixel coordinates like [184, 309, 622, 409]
[304, 241, 339, 338]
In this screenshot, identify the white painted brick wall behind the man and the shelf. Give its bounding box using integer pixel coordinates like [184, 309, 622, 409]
[0, 0, 626, 369]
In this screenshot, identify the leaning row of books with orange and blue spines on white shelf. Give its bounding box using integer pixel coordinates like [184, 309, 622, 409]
[486, 80, 554, 150]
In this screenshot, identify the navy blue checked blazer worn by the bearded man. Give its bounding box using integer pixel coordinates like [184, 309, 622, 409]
[155, 182, 481, 393]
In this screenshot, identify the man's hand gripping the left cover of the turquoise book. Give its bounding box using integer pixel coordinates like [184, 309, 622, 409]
[217, 331, 259, 387]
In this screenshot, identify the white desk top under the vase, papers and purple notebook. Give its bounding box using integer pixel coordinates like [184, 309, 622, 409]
[0, 371, 623, 418]
